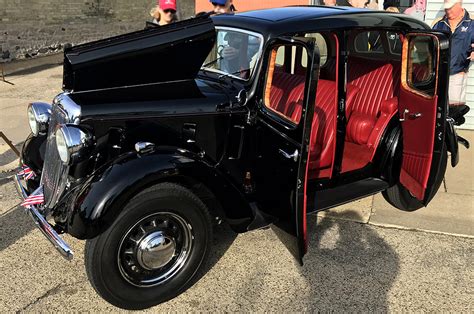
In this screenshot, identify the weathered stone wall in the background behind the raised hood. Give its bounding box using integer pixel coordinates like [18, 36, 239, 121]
[0, 0, 194, 62]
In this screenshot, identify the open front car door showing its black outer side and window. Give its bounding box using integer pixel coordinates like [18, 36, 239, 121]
[254, 38, 319, 264]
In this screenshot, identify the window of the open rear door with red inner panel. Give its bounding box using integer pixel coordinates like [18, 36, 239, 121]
[406, 36, 437, 96]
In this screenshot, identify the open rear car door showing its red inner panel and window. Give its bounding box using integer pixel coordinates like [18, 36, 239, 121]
[398, 32, 449, 206]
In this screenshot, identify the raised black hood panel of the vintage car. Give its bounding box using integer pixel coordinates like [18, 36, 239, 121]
[63, 18, 216, 92]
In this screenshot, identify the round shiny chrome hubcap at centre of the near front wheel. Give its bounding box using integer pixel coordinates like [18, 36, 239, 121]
[137, 231, 176, 270]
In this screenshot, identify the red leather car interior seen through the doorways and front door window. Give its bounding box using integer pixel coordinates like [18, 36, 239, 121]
[264, 30, 433, 184]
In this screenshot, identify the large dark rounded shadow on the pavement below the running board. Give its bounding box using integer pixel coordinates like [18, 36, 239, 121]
[231, 212, 400, 312]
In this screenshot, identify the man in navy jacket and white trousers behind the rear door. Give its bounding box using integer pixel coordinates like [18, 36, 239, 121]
[433, 0, 474, 125]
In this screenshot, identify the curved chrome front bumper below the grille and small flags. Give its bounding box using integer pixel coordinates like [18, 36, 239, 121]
[15, 174, 74, 260]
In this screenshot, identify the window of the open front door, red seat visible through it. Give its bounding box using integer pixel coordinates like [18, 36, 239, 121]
[264, 45, 306, 124]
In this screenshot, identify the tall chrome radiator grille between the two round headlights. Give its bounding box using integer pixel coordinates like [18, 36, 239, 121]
[41, 104, 68, 208]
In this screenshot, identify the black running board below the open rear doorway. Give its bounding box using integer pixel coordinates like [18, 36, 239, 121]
[308, 178, 389, 213]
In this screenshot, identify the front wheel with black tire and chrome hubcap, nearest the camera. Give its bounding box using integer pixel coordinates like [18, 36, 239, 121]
[85, 183, 212, 310]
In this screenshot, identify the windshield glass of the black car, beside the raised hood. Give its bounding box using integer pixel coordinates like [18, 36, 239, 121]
[201, 27, 263, 80]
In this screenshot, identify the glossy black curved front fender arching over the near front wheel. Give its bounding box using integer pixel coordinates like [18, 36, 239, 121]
[67, 149, 251, 239]
